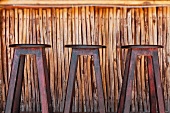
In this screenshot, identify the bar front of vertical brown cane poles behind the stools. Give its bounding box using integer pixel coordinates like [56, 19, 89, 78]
[0, 6, 170, 112]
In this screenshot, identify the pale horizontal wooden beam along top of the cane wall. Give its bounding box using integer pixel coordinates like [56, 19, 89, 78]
[0, 0, 170, 7]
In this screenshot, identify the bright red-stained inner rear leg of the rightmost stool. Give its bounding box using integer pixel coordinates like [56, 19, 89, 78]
[147, 56, 156, 113]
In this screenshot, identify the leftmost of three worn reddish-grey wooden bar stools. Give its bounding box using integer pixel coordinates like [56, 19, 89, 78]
[5, 44, 52, 113]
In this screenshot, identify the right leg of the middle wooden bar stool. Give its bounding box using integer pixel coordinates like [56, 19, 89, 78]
[93, 49, 105, 113]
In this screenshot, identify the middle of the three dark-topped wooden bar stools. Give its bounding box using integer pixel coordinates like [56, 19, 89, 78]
[64, 45, 106, 113]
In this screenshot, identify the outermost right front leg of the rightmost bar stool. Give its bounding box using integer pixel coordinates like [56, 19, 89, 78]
[153, 51, 165, 113]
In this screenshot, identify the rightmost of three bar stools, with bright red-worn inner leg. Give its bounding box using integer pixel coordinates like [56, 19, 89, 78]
[118, 45, 165, 113]
